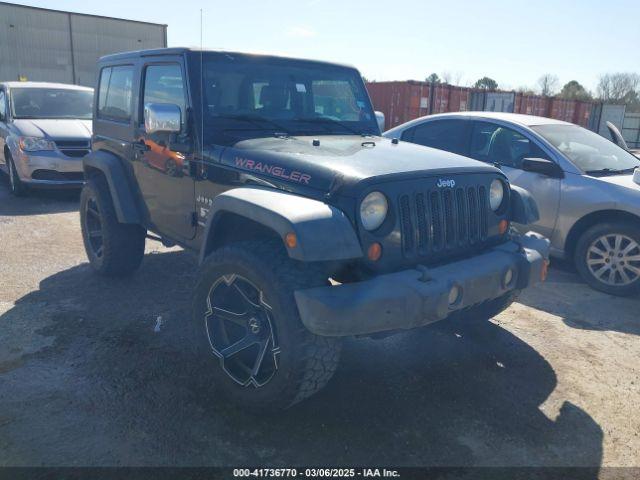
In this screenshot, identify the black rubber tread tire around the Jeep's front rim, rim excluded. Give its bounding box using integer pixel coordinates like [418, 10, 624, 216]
[192, 240, 342, 411]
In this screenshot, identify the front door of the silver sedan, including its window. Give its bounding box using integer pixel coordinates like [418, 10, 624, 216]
[469, 121, 561, 238]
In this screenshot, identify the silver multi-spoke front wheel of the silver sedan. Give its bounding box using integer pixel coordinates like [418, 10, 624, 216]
[575, 223, 640, 296]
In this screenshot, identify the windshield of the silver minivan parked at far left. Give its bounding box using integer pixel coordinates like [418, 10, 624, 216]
[11, 88, 93, 120]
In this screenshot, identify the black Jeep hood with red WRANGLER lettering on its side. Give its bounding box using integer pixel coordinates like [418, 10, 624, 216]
[222, 135, 499, 191]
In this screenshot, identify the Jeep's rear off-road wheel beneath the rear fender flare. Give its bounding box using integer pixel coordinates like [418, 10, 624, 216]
[80, 175, 146, 277]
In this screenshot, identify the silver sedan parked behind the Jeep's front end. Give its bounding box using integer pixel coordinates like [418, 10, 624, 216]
[384, 112, 640, 295]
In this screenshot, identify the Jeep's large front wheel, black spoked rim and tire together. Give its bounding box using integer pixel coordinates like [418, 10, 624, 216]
[192, 240, 341, 411]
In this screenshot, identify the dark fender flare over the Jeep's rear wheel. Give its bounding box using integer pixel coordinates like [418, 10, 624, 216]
[82, 151, 142, 224]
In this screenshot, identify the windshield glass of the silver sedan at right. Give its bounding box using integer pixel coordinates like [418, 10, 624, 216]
[531, 125, 640, 175]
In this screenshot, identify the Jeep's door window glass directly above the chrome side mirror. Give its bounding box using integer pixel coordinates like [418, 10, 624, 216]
[142, 64, 186, 123]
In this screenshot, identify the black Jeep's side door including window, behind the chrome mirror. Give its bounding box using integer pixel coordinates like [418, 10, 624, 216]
[134, 57, 196, 240]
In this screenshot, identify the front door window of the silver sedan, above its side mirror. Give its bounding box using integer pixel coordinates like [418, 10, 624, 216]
[469, 122, 549, 168]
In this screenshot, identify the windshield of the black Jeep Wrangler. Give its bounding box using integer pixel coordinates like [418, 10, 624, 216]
[192, 53, 379, 144]
